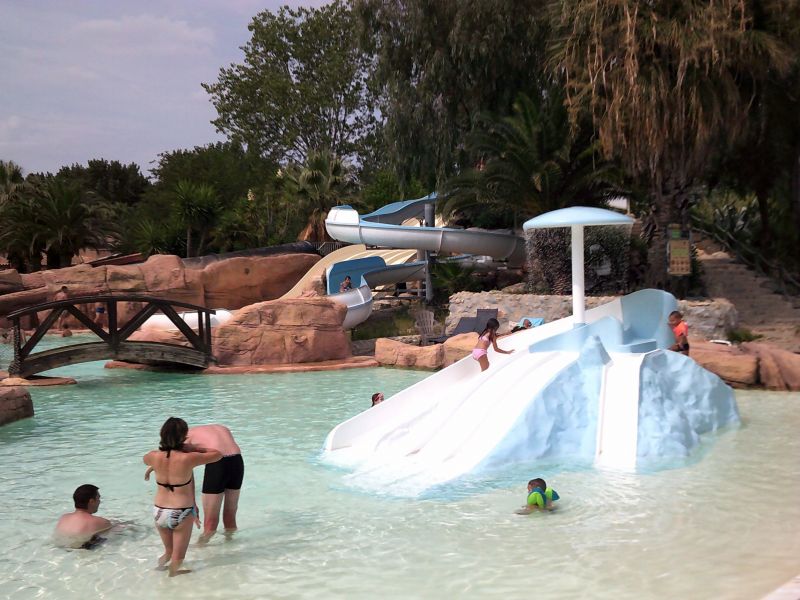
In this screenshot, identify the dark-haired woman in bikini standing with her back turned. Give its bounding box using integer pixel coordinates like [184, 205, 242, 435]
[144, 417, 222, 577]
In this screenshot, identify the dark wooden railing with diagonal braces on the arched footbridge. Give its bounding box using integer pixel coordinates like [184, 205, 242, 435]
[7, 295, 216, 376]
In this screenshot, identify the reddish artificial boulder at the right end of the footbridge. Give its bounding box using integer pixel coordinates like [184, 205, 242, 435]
[130, 298, 350, 367]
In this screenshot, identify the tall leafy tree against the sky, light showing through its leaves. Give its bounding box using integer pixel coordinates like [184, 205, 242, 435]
[203, 0, 375, 163]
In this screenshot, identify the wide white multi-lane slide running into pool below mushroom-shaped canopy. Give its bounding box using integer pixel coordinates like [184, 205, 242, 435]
[324, 290, 700, 495]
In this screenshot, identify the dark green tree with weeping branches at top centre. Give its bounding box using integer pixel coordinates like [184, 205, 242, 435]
[355, 0, 546, 189]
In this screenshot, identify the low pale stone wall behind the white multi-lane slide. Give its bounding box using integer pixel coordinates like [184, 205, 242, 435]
[446, 291, 738, 339]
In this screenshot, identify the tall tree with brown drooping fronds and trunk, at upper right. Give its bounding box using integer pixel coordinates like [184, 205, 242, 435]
[551, 0, 791, 287]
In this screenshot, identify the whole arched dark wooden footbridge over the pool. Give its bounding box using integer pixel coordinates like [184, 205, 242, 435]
[7, 295, 215, 377]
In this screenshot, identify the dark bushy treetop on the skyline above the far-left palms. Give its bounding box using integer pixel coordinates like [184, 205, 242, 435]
[56, 159, 150, 205]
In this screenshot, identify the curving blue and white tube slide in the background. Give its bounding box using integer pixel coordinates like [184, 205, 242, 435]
[325, 193, 525, 329]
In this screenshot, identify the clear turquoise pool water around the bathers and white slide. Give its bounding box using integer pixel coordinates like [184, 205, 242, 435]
[0, 340, 800, 599]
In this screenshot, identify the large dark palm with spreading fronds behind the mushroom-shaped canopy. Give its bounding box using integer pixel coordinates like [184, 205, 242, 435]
[442, 90, 619, 227]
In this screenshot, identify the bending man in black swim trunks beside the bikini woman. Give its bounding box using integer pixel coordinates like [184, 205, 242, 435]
[186, 425, 244, 543]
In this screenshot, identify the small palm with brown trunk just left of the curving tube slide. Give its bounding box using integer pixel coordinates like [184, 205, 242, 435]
[282, 150, 352, 242]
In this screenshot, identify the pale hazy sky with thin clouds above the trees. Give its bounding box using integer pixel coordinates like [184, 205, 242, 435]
[0, 0, 324, 175]
